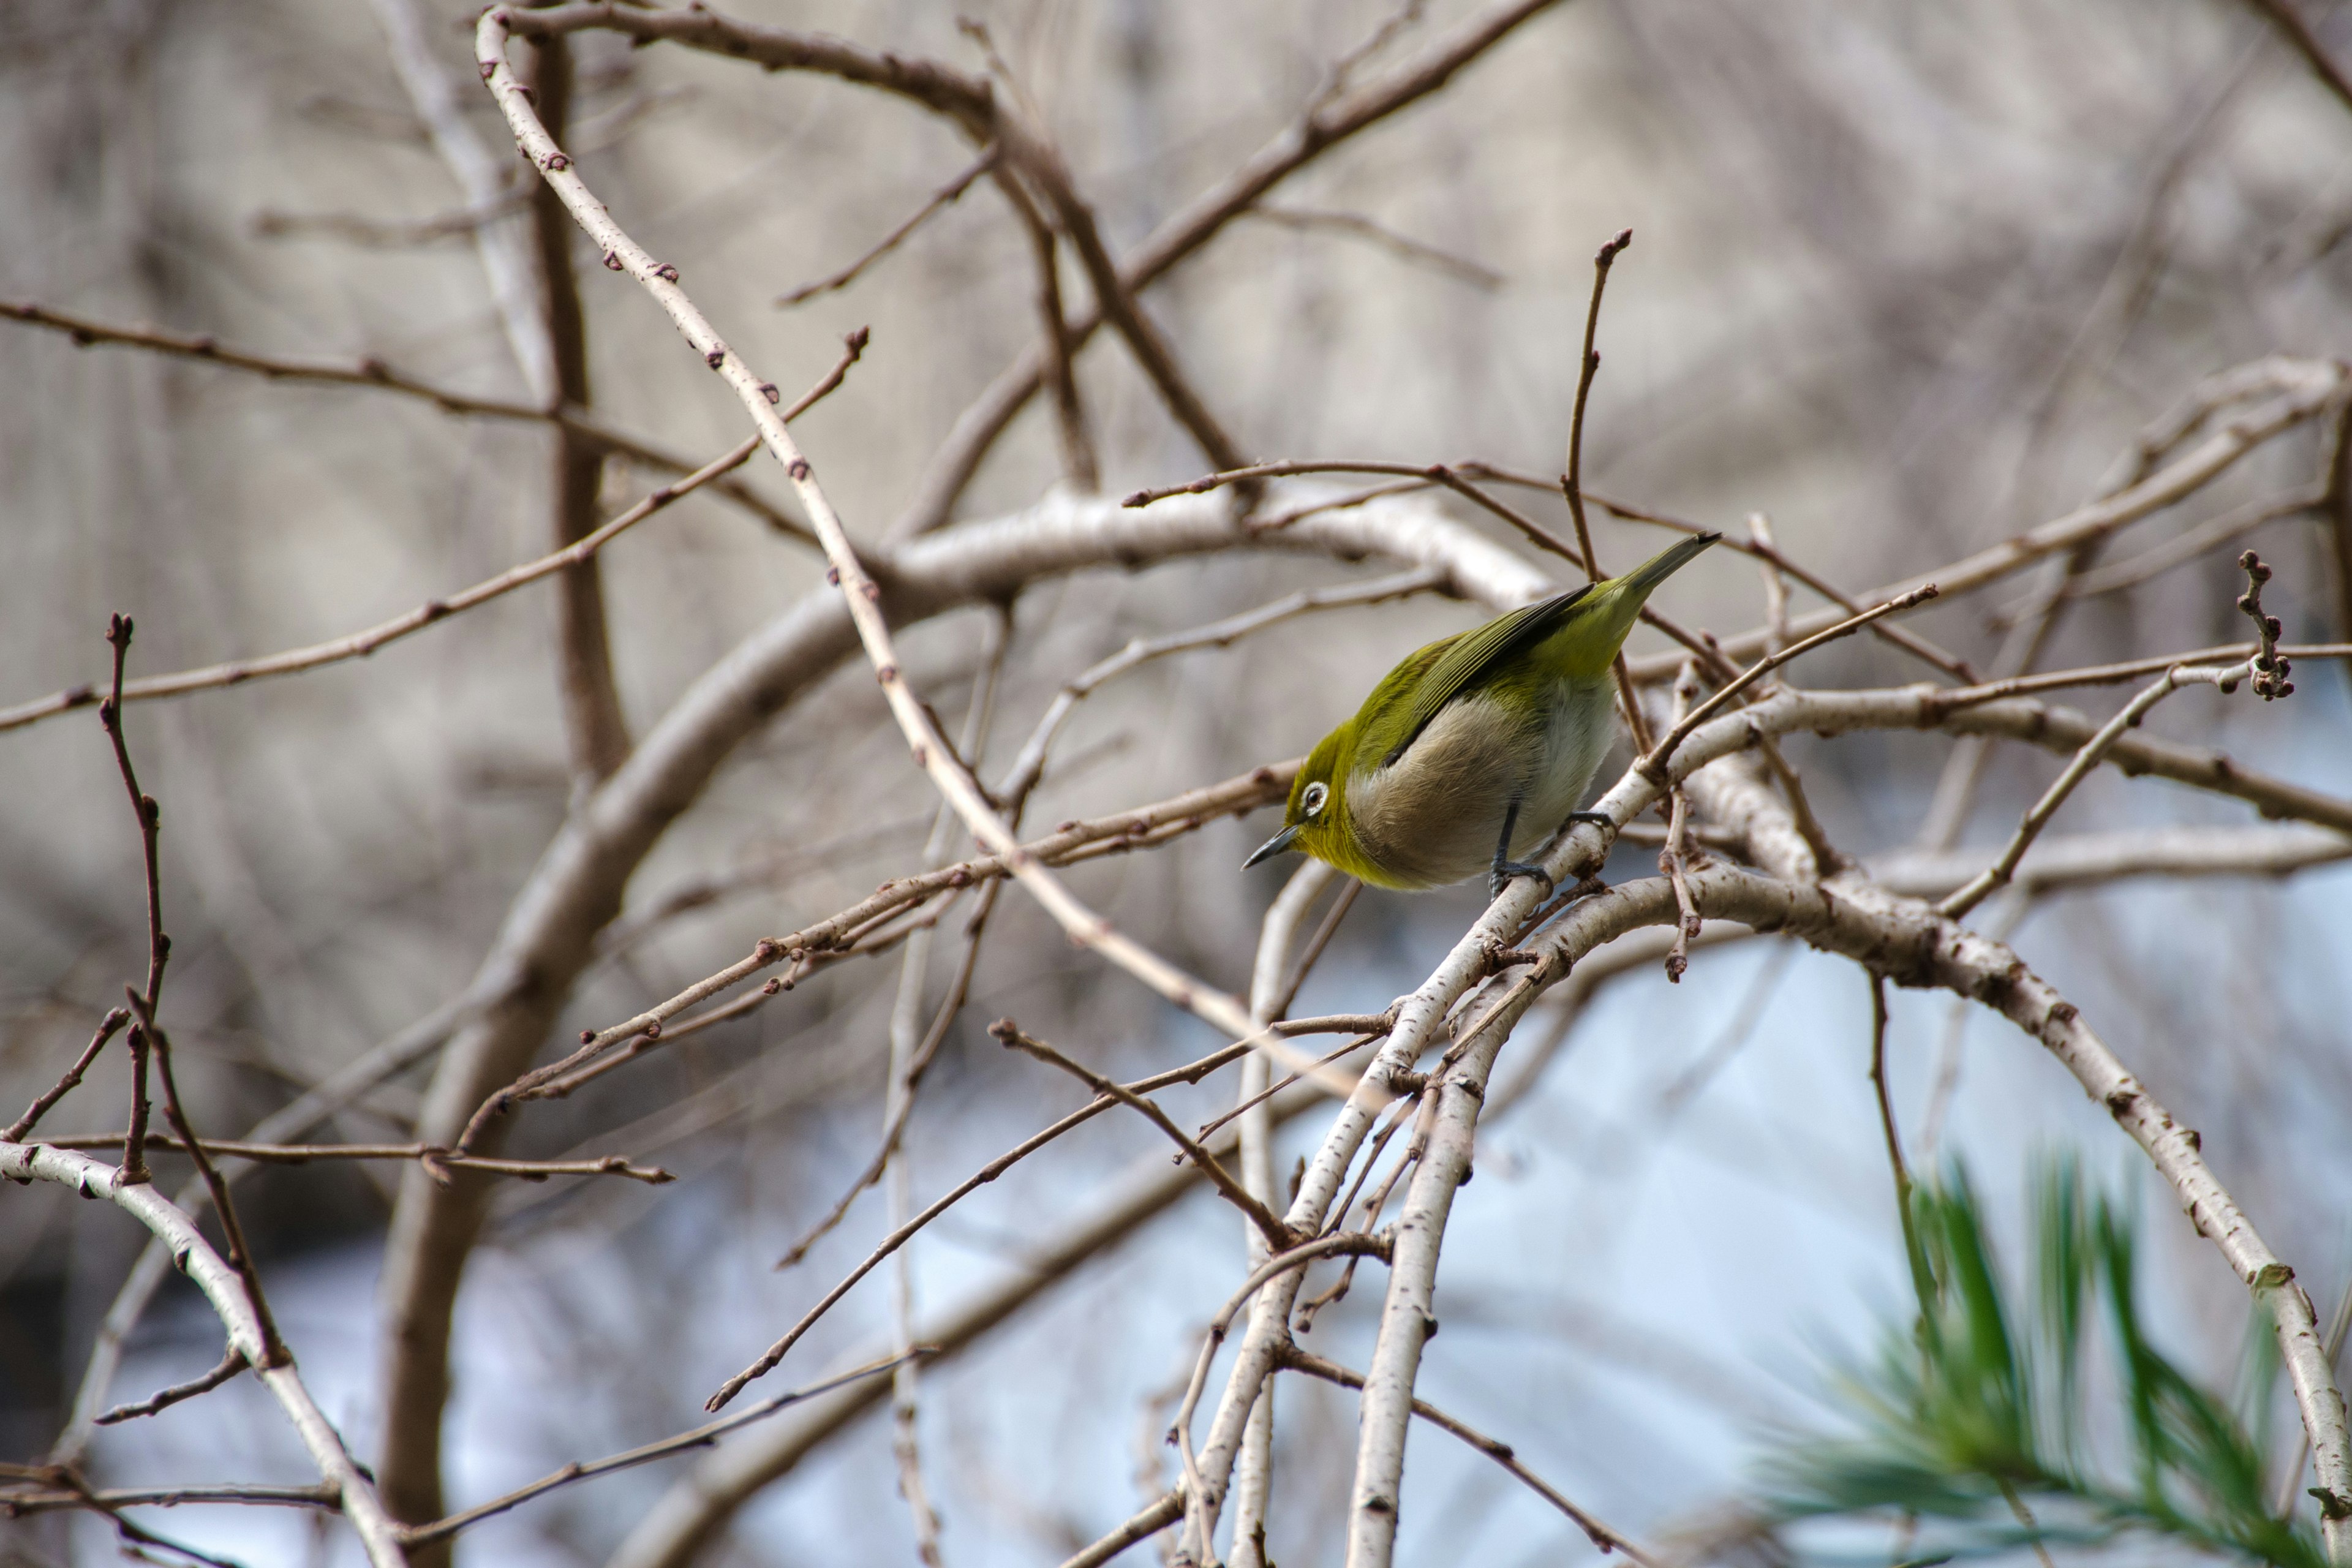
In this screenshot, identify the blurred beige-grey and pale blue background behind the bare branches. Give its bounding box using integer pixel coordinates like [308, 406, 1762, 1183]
[0, 0, 2352, 1568]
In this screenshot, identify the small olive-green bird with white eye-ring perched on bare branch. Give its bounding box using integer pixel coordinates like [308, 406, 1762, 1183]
[1242, 533, 1722, 895]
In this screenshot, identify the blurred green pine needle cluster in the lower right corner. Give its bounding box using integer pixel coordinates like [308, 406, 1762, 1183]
[1766, 1161, 2324, 1568]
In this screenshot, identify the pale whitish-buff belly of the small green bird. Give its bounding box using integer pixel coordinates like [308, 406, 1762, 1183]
[1348, 677, 1616, 886]
